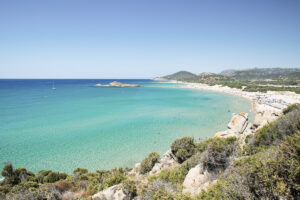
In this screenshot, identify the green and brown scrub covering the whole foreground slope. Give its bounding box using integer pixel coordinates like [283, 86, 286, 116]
[0, 105, 300, 200]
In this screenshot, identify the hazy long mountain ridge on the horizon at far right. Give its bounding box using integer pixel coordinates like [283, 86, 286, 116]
[220, 68, 300, 80]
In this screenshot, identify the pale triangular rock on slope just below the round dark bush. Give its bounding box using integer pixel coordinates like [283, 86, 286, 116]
[150, 150, 179, 175]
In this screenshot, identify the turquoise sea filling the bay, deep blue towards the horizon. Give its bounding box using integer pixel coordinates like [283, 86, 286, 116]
[0, 79, 252, 173]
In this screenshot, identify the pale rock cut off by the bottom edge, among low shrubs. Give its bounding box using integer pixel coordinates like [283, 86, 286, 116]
[92, 184, 128, 200]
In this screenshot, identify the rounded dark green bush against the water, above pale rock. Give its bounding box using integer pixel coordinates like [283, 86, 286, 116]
[171, 137, 195, 163]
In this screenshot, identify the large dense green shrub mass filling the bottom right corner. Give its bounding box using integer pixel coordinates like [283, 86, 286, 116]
[199, 133, 300, 200]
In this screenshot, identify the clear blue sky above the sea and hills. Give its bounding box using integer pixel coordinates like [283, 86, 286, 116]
[0, 0, 300, 78]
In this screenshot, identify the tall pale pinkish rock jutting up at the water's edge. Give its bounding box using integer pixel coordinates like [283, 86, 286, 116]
[215, 112, 250, 137]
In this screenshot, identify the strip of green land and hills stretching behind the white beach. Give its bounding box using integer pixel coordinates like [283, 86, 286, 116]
[163, 68, 300, 94]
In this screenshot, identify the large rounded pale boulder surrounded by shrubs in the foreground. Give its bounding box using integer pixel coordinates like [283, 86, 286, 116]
[182, 165, 216, 196]
